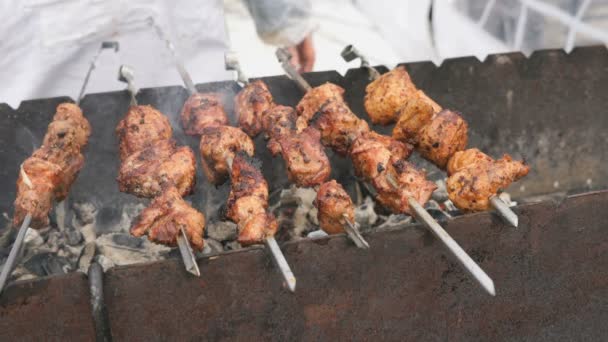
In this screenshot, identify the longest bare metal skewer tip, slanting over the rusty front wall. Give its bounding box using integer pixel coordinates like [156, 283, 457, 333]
[408, 197, 496, 296]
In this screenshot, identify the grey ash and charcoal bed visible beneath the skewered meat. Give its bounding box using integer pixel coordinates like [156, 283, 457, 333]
[0, 180, 516, 280]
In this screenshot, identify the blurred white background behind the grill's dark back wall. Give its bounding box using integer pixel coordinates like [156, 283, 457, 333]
[0, 0, 608, 106]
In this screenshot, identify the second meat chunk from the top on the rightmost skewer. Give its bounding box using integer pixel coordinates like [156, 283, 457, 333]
[393, 93, 435, 145]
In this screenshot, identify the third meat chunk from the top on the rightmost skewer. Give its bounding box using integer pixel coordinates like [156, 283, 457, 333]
[418, 110, 468, 169]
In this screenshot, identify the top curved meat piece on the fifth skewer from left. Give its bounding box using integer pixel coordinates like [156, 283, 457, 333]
[296, 82, 344, 131]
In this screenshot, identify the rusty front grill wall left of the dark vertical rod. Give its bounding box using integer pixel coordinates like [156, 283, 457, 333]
[0, 273, 95, 341]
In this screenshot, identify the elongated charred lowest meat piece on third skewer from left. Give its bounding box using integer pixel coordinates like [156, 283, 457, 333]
[226, 152, 278, 245]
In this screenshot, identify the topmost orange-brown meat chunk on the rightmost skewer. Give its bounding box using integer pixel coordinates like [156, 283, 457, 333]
[364, 66, 417, 125]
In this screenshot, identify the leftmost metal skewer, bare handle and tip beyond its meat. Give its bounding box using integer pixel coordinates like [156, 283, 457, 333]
[0, 42, 118, 293]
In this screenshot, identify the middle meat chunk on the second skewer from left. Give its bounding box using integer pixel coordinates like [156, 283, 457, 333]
[117, 139, 196, 198]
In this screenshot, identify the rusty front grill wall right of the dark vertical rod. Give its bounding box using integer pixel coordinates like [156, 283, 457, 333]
[105, 192, 608, 341]
